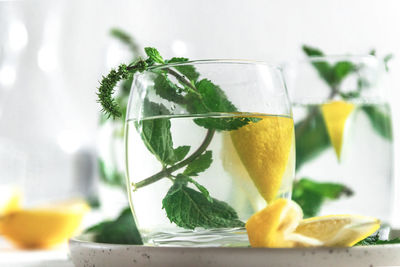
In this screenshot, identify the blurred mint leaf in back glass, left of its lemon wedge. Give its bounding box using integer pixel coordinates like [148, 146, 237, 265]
[295, 106, 331, 170]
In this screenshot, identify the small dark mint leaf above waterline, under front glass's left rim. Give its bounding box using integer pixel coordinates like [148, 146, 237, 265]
[154, 73, 185, 104]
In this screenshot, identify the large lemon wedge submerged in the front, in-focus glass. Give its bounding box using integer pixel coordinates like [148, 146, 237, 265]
[230, 116, 294, 202]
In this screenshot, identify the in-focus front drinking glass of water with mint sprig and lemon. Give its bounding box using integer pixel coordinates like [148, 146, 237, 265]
[125, 60, 295, 246]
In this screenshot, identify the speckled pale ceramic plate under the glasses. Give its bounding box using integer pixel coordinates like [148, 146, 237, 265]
[69, 237, 400, 267]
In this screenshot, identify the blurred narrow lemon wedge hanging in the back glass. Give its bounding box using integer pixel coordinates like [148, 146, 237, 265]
[321, 101, 354, 160]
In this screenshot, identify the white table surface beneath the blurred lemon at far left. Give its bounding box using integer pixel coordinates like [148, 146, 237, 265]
[0, 237, 74, 267]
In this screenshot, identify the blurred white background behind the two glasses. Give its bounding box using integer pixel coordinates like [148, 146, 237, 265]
[0, 0, 400, 260]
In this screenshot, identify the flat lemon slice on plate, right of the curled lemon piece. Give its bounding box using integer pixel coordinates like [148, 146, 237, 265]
[295, 215, 380, 247]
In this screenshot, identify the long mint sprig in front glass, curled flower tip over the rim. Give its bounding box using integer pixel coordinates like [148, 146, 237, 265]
[98, 47, 250, 229]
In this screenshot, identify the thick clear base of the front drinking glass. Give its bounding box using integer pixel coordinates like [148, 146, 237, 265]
[144, 228, 250, 247]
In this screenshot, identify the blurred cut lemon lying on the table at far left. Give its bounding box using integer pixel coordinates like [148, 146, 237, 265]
[1, 200, 89, 248]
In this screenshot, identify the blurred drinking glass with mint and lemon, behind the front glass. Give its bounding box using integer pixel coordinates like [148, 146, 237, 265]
[285, 56, 393, 222]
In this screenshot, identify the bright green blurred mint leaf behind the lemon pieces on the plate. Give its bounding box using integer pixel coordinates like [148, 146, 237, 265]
[292, 178, 353, 218]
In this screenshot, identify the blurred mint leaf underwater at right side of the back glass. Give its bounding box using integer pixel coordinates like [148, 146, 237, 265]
[361, 105, 393, 141]
